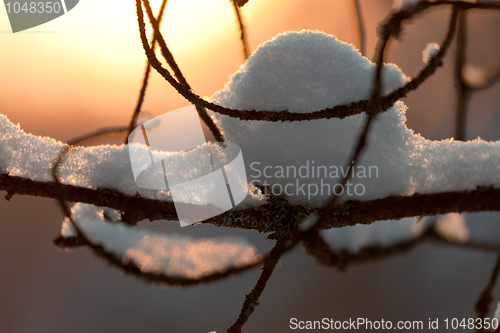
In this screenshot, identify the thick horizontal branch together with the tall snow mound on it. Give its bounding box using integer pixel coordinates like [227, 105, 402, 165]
[0, 27, 500, 231]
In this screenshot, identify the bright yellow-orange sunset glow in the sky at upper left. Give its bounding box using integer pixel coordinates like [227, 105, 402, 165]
[0, 0, 350, 140]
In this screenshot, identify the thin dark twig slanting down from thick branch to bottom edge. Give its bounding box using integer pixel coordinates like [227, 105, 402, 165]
[227, 238, 287, 333]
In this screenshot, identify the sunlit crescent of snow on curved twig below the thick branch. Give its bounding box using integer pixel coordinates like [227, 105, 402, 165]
[62, 204, 259, 279]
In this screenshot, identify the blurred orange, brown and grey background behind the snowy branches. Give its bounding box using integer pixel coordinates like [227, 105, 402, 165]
[0, 0, 500, 333]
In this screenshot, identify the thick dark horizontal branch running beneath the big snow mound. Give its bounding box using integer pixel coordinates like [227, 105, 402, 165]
[0, 174, 500, 232]
